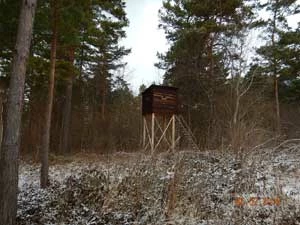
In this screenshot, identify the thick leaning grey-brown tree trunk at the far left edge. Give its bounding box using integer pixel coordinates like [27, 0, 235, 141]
[0, 0, 37, 225]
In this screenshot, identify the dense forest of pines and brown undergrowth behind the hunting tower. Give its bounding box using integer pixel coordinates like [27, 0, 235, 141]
[0, 0, 300, 155]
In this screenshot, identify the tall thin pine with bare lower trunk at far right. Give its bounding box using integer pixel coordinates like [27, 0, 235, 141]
[257, 0, 299, 134]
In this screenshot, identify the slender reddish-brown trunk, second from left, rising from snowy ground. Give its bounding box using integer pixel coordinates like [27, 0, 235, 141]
[40, 0, 57, 188]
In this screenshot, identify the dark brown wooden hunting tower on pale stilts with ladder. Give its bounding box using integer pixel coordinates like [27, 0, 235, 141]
[142, 85, 195, 153]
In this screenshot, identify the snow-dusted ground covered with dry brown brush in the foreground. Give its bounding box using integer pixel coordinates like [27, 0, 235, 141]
[18, 145, 300, 225]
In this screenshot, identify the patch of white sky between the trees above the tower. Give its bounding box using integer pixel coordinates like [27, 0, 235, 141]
[122, 0, 168, 93]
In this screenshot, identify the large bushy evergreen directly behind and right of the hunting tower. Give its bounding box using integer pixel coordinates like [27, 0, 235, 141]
[157, 0, 252, 148]
